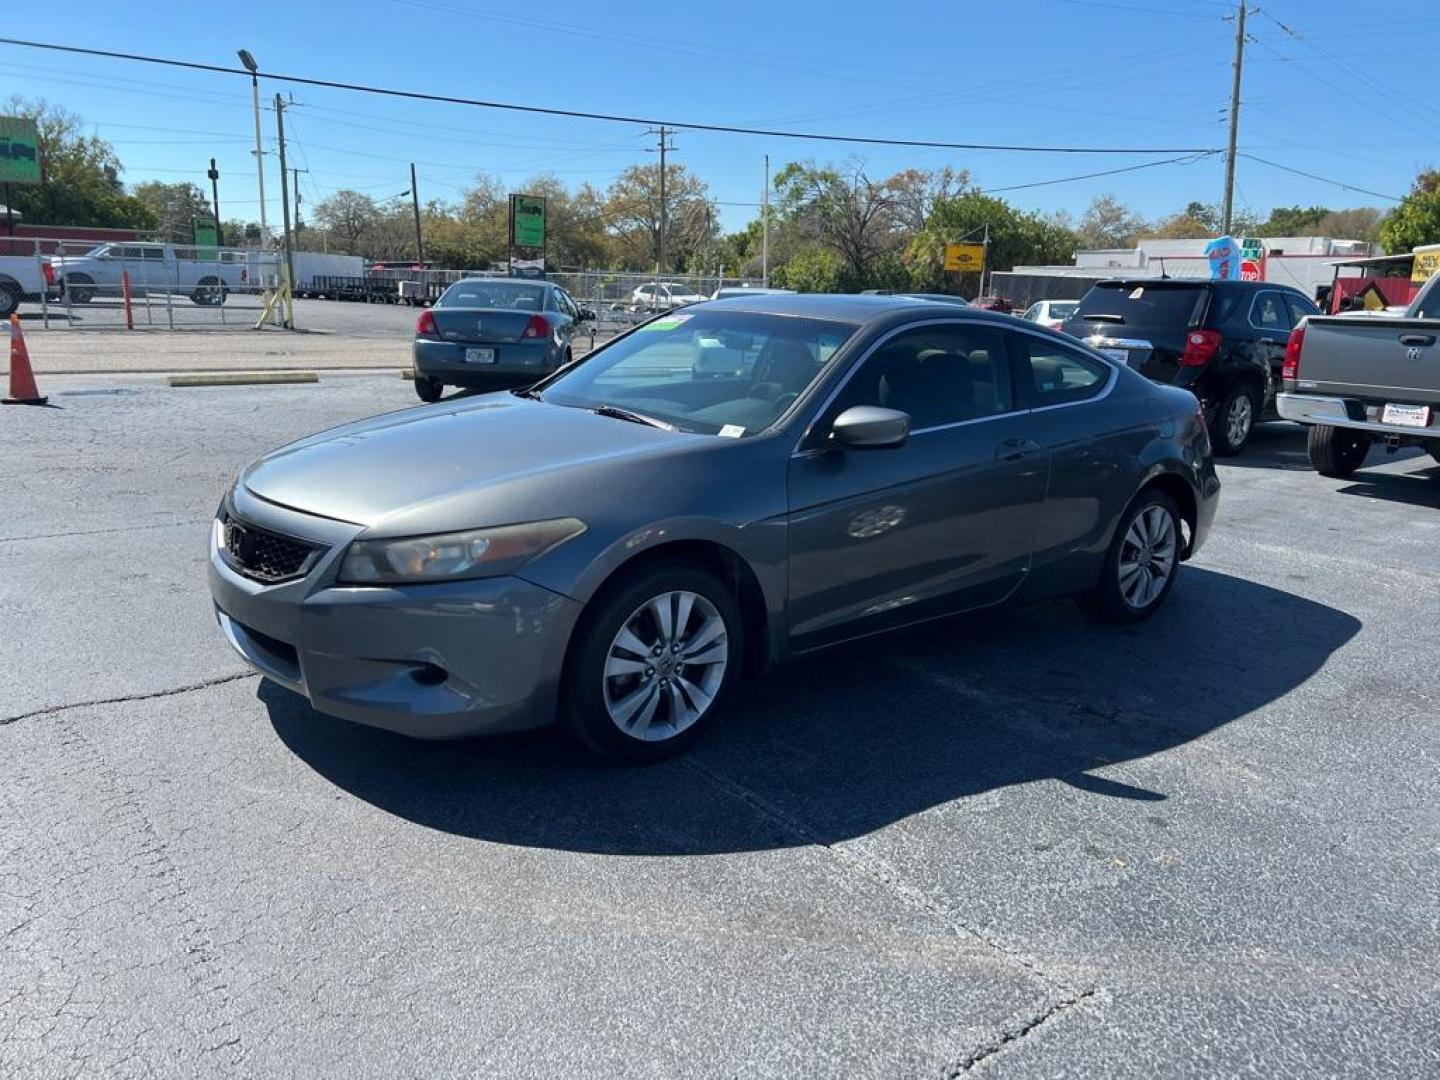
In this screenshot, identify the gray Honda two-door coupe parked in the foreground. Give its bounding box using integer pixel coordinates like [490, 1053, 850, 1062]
[209, 295, 1220, 762]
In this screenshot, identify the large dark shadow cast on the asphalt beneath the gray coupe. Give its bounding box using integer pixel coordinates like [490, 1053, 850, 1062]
[258, 566, 1361, 855]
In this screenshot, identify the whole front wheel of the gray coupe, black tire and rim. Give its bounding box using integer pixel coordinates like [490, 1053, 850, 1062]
[560, 562, 744, 765]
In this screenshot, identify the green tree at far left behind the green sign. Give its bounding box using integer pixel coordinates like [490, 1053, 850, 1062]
[0, 96, 156, 229]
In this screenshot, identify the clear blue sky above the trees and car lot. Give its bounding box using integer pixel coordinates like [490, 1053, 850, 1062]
[0, 0, 1440, 229]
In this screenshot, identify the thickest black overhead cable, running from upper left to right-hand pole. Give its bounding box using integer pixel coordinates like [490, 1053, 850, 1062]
[0, 37, 1211, 154]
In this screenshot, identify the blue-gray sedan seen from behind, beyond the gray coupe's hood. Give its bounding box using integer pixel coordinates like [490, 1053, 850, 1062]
[412, 278, 595, 402]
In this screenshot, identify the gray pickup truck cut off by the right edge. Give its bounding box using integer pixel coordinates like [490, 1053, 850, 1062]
[1276, 274, 1440, 477]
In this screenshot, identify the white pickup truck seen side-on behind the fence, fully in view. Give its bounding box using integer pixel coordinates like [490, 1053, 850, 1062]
[50, 240, 258, 304]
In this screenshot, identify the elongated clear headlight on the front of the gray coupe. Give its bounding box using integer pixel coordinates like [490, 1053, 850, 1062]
[340, 517, 585, 585]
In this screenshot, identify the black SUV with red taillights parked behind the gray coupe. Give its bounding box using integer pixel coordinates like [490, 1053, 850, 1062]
[1061, 278, 1320, 454]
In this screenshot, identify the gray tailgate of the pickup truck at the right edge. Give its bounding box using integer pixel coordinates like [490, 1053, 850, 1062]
[1296, 315, 1440, 405]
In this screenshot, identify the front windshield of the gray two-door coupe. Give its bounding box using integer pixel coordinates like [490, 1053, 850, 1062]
[541, 308, 855, 438]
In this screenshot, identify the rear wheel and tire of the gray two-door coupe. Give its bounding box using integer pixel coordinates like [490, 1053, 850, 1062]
[1084, 488, 1181, 622]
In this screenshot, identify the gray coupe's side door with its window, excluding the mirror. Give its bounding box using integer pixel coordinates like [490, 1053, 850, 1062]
[788, 320, 1045, 649]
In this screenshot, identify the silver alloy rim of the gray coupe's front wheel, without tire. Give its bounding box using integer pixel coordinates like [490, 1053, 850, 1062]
[600, 590, 730, 742]
